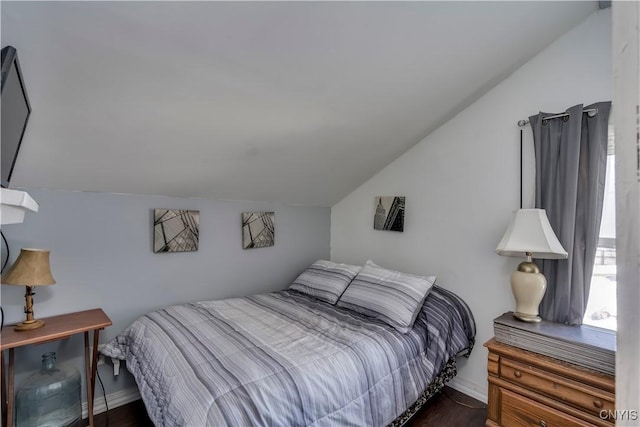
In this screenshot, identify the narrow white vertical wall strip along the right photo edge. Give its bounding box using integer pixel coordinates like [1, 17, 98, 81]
[613, 2, 640, 426]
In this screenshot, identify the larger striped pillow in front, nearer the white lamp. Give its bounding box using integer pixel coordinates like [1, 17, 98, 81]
[336, 261, 436, 333]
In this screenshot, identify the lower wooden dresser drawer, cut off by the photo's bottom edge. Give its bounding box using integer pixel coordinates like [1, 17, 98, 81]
[500, 390, 593, 427]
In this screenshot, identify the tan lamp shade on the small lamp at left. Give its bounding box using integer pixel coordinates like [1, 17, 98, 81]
[1, 248, 56, 286]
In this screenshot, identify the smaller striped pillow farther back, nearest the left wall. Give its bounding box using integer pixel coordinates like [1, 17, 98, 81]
[289, 260, 362, 304]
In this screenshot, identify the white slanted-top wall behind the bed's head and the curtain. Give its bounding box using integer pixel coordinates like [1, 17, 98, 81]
[331, 9, 612, 400]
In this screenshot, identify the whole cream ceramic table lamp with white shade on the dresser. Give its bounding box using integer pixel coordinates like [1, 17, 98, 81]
[496, 209, 567, 322]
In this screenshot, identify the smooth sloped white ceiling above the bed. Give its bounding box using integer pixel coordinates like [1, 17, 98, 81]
[1, 1, 598, 206]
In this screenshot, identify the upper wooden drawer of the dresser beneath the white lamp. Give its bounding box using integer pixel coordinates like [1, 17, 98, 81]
[500, 358, 615, 416]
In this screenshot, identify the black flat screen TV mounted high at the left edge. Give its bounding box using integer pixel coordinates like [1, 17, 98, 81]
[0, 46, 31, 188]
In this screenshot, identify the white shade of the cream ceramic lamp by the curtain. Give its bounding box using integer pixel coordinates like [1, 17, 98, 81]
[496, 209, 567, 259]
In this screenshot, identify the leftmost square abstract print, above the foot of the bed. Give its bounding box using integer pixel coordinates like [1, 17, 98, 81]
[153, 209, 200, 253]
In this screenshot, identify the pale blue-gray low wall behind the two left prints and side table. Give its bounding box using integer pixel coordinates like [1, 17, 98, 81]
[1, 189, 330, 398]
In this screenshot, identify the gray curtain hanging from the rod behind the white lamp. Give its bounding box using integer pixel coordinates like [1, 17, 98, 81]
[529, 102, 611, 325]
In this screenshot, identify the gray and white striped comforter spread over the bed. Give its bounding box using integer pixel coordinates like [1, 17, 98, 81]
[102, 286, 475, 426]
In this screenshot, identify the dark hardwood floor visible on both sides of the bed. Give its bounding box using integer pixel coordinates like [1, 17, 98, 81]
[86, 387, 486, 427]
